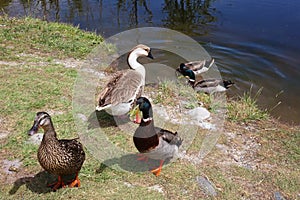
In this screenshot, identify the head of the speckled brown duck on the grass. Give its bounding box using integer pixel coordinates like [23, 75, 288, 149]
[28, 112, 52, 135]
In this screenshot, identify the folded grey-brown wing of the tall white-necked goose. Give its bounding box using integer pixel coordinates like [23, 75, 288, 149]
[98, 70, 143, 107]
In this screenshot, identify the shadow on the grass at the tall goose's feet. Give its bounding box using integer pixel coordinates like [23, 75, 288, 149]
[88, 110, 130, 129]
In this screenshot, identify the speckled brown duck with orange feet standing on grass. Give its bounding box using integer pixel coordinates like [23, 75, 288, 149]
[28, 112, 85, 191]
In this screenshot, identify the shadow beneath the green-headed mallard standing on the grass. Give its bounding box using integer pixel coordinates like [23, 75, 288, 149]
[96, 154, 170, 173]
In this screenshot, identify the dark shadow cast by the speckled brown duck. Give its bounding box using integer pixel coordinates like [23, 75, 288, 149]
[9, 171, 56, 195]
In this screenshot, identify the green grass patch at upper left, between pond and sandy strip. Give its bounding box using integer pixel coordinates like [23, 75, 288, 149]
[0, 16, 103, 60]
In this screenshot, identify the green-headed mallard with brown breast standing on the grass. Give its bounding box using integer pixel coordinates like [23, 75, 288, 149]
[133, 97, 182, 176]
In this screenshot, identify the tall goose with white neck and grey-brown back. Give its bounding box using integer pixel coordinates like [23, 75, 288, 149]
[96, 44, 153, 116]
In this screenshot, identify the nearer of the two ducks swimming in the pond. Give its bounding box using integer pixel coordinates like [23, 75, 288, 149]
[182, 69, 234, 94]
